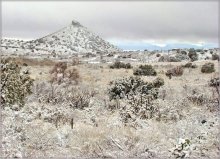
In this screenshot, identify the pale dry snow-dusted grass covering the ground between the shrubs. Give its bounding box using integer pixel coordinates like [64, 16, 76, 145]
[3, 57, 220, 159]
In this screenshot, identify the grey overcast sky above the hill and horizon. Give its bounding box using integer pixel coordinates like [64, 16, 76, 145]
[2, 1, 218, 48]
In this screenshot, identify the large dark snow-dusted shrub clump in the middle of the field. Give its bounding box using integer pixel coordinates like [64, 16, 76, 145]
[108, 76, 164, 123]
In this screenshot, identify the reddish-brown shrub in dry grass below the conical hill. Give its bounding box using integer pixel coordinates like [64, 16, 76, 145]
[50, 62, 80, 84]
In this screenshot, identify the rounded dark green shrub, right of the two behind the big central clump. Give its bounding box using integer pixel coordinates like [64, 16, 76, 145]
[133, 65, 157, 76]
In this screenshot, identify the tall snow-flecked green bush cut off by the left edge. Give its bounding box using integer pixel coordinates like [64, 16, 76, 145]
[1, 59, 33, 106]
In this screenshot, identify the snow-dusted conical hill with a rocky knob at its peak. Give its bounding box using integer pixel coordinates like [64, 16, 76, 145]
[24, 21, 119, 54]
